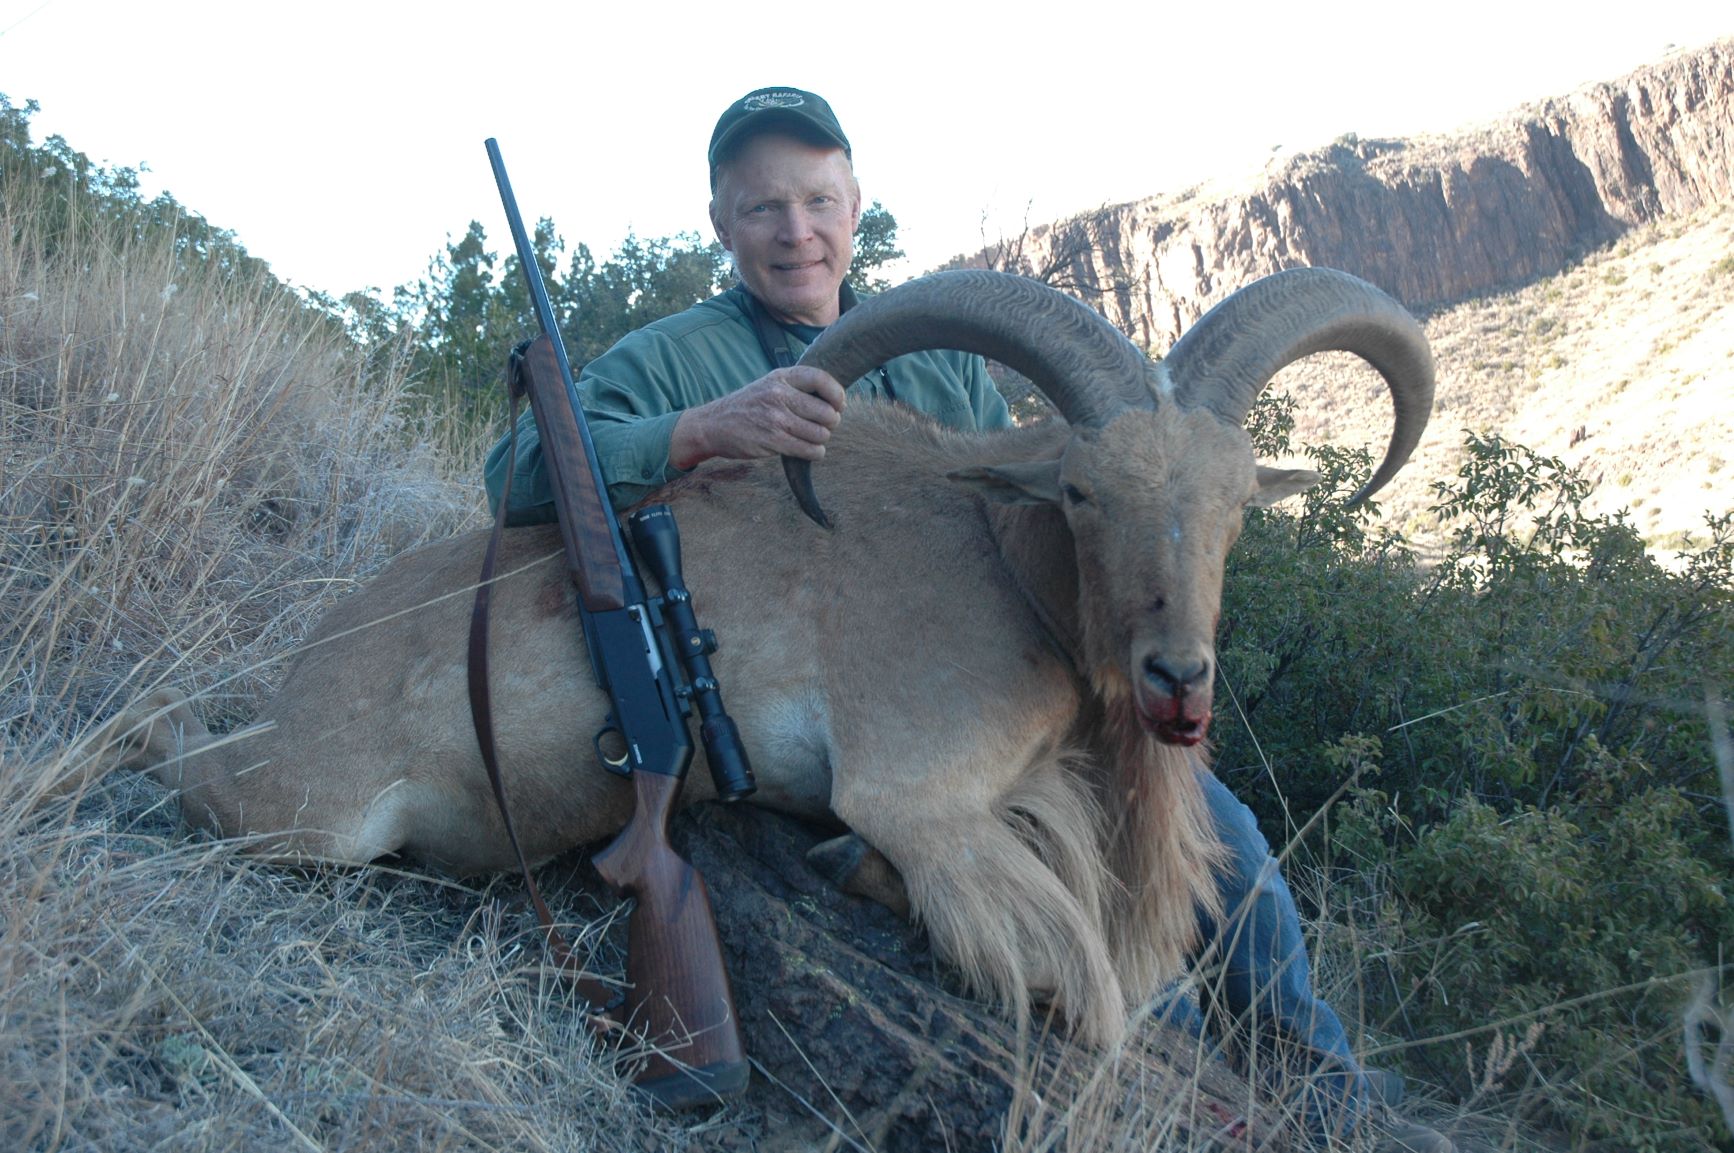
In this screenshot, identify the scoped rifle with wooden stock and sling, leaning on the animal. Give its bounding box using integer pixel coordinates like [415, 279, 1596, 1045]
[472, 139, 754, 1108]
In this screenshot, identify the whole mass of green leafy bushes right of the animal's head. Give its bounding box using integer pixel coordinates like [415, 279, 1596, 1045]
[1217, 402, 1734, 1150]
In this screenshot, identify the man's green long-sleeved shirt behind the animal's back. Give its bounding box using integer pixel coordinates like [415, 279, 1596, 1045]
[484, 284, 1011, 525]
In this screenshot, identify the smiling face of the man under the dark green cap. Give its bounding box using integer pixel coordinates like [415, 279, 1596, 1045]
[711, 135, 862, 324]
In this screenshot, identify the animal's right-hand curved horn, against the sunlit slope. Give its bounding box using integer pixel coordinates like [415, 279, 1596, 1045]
[1162, 269, 1434, 506]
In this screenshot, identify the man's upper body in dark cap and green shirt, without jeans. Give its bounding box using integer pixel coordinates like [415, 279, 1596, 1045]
[486, 88, 1011, 524]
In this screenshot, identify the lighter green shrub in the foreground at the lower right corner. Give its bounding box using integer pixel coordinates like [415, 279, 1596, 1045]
[1333, 752, 1734, 1151]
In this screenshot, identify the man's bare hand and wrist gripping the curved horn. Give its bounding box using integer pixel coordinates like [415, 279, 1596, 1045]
[668, 364, 843, 468]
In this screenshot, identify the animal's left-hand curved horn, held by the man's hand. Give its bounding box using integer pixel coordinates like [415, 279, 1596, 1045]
[782, 269, 1155, 527]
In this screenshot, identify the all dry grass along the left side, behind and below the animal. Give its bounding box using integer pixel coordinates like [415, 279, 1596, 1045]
[0, 132, 710, 1153]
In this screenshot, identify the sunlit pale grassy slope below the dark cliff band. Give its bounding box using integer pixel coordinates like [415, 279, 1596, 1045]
[1278, 205, 1734, 550]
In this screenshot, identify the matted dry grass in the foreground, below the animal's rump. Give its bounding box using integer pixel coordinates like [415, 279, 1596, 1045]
[0, 790, 634, 1150]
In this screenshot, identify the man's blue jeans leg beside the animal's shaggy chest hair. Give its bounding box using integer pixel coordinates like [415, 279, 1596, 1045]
[1170, 773, 1372, 1136]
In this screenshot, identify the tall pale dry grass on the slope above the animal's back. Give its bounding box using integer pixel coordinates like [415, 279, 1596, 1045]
[0, 169, 475, 758]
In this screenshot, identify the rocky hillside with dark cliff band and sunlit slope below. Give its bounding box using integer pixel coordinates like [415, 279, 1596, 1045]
[959, 40, 1734, 544]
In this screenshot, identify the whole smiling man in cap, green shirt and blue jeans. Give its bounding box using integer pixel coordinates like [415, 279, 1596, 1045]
[487, 88, 1453, 1153]
